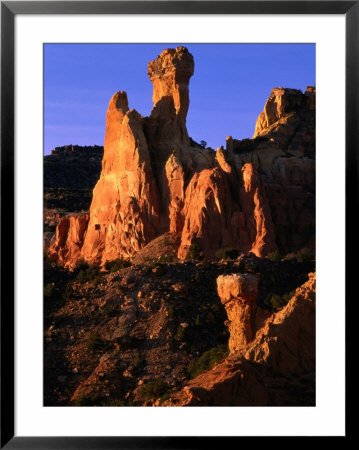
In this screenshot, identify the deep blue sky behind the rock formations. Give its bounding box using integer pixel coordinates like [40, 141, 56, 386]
[44, 43, 315, 154]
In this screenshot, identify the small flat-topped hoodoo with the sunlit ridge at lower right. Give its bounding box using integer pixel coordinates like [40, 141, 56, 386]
[164, 273, 316, 406]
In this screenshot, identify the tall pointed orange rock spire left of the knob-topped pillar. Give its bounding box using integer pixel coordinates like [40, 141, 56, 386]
[82, 104, 159, 264]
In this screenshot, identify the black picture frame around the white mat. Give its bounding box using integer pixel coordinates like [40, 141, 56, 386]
[0, 0, 359, 450]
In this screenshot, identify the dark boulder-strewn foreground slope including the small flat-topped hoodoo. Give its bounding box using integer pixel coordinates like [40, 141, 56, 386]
[44, 253, 314, 406]
